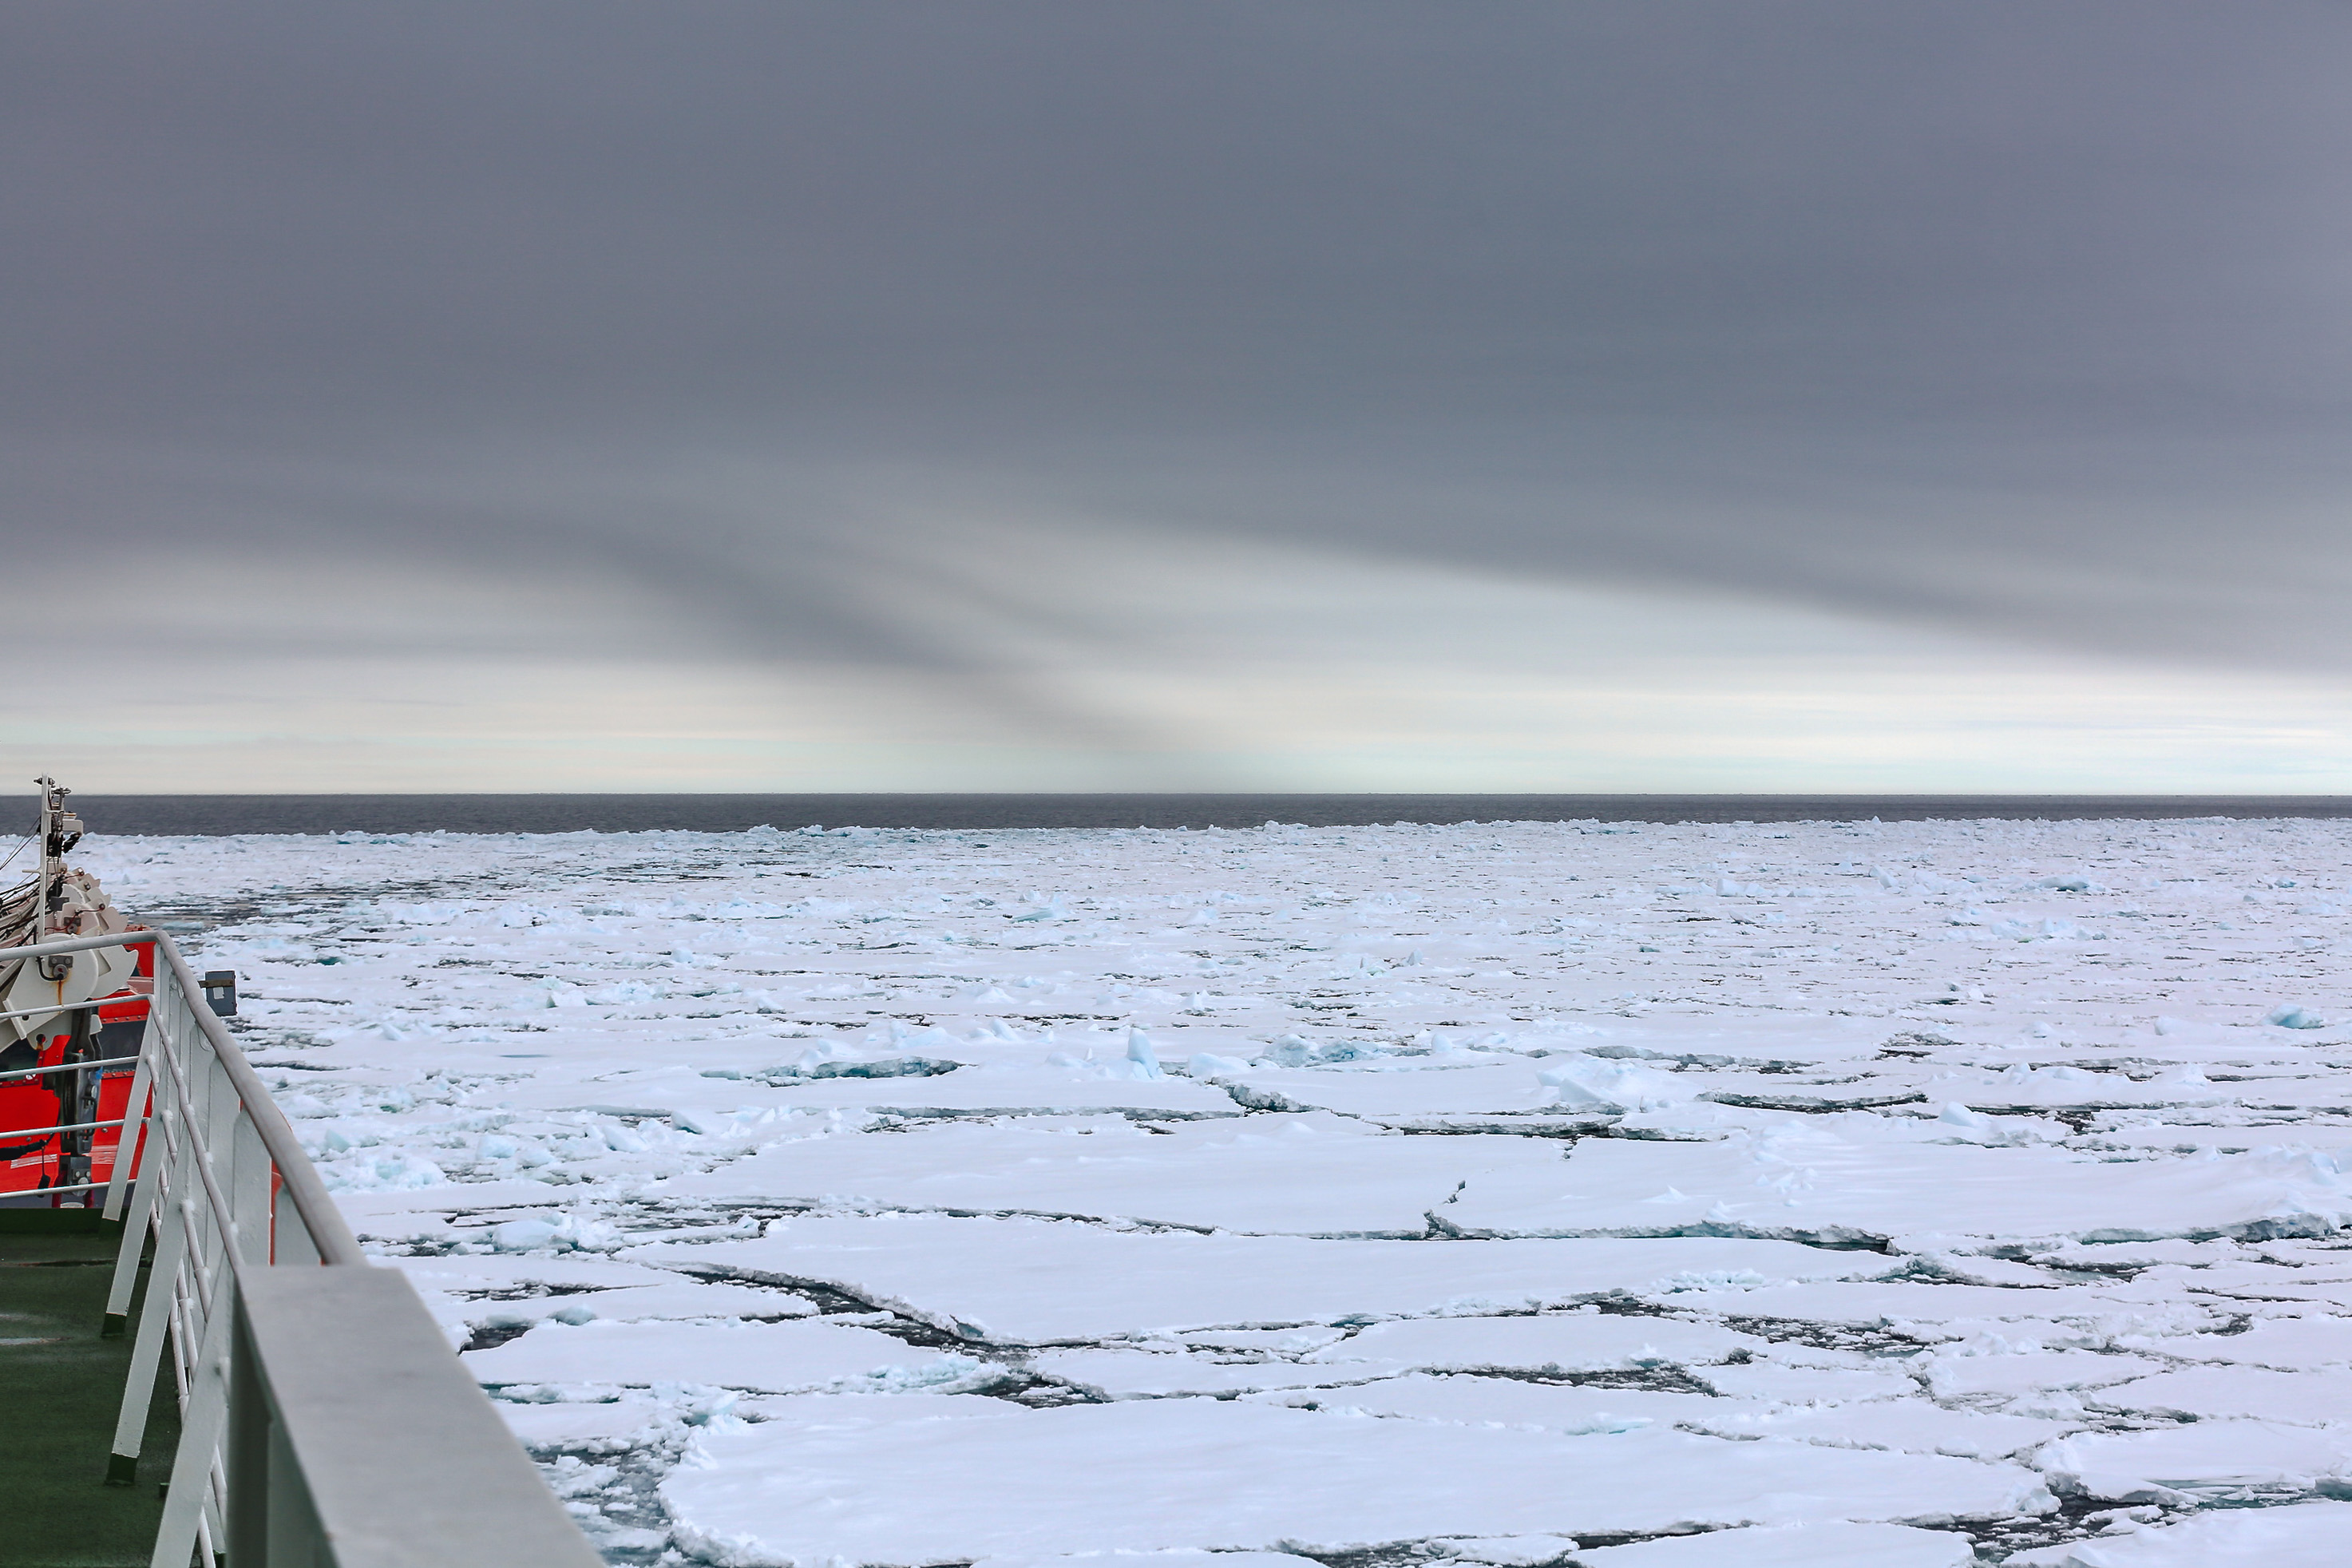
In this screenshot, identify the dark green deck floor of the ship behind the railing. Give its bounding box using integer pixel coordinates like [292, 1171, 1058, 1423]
[0, 1208, 179, 1568]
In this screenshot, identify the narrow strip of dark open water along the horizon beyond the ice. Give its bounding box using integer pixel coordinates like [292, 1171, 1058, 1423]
[50, 794, 2352, 834]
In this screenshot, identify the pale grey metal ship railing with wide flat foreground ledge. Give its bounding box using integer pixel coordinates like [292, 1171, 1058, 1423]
[5, 931, 602, 1568]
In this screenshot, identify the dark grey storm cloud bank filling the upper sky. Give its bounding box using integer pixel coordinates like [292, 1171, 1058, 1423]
[0, 0, 2352, 665]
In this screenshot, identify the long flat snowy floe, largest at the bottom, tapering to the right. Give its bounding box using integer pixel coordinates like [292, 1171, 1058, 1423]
[663, 1399, 2053, 1563]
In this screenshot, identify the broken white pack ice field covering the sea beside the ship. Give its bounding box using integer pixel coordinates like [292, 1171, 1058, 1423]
[85, 821, 2352, 1568]
